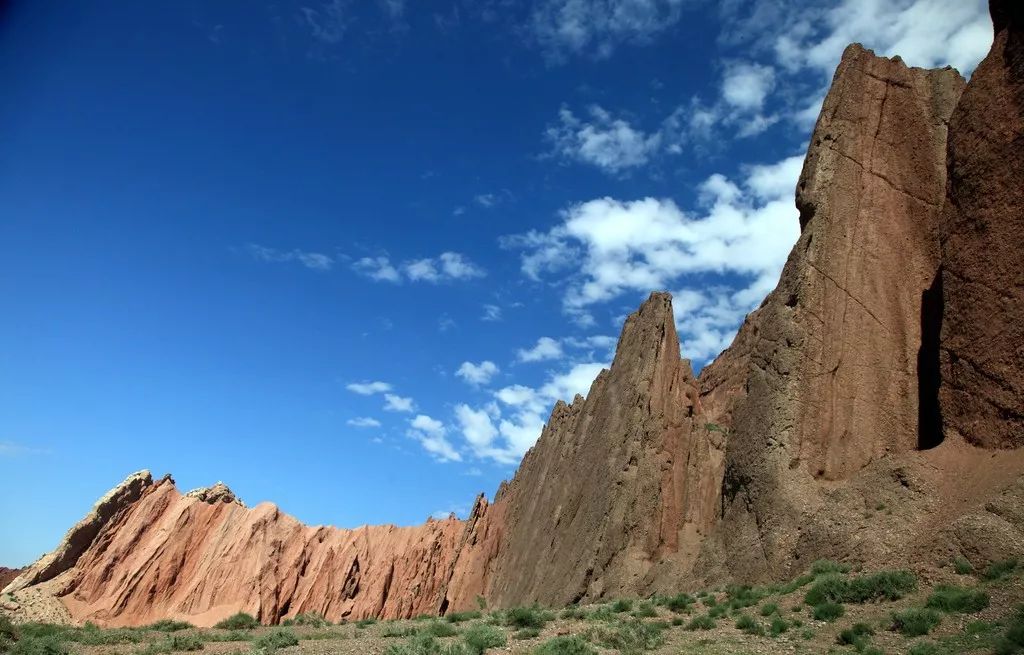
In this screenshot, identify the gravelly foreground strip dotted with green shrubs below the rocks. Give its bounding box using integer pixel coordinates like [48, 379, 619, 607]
[0, 560, 1024, 655]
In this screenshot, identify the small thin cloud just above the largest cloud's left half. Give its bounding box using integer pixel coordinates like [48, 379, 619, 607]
[545, 104, 662, 174]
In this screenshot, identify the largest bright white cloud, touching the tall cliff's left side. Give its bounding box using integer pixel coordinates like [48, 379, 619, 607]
[513, 157, 802, 360]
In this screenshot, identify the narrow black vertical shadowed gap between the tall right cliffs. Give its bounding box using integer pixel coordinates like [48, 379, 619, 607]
[918, 267, 943, 450]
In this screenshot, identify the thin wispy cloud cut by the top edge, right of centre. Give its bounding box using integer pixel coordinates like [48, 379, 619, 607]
[528, 0, 683, 60]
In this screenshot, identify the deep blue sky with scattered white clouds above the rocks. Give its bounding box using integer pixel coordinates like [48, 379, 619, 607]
[0, 0, 991, 565]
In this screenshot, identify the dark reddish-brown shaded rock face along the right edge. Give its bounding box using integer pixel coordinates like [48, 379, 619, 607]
[941, 1, 1024, 448]
